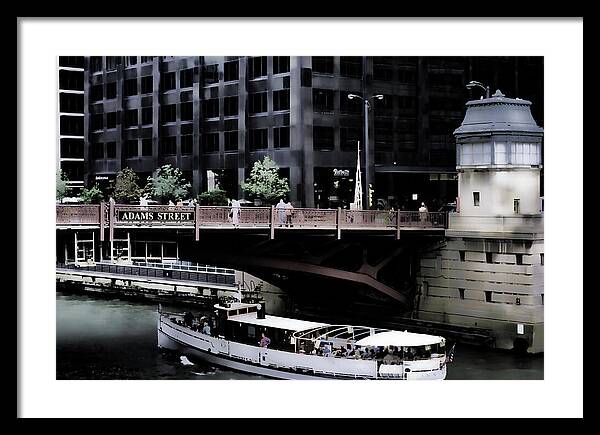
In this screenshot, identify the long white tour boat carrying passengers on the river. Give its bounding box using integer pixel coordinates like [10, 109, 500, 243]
[157, 302, 446, 380]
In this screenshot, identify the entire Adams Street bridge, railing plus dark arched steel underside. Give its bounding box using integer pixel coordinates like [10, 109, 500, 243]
[56, 203, 447, 309]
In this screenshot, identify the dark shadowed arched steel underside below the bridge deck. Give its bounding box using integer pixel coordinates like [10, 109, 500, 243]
[179, 231, 442, 313]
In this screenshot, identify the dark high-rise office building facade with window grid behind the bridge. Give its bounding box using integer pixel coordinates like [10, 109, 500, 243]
[67, 56, 543, 209]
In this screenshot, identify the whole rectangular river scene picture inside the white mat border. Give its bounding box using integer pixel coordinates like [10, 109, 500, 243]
[56, 56, 544, 381]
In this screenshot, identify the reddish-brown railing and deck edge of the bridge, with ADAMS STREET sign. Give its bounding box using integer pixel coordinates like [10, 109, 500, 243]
[56, 203, 447, 241]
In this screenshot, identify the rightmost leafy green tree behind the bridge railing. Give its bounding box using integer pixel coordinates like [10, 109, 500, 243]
[242, 156, 290, 204]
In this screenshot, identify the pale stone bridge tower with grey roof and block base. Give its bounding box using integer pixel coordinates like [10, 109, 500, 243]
[417, 91, 544, 352]
